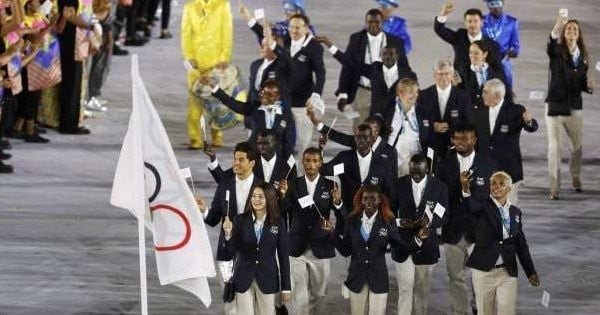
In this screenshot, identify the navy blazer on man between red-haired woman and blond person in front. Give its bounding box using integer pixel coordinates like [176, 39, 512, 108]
[392, 175, 448, 265]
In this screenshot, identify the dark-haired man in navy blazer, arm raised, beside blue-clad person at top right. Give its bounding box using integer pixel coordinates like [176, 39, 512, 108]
[433, 1, 500, 77]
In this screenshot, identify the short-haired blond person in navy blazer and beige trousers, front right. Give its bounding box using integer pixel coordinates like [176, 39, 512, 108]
[461, 172, 540, 314]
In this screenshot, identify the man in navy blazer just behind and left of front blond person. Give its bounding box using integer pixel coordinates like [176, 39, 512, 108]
[437, 124, 497, 314]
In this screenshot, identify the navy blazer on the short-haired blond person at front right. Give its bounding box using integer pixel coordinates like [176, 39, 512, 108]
[467, 197, 536, 277]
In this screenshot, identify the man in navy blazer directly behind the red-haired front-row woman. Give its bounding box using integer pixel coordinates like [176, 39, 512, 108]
[321, 124, 393, 210]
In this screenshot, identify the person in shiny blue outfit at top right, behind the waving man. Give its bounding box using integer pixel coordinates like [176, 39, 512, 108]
[481, 0, 521, 88]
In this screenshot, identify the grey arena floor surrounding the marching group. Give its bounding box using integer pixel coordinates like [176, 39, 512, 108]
[0, 0, 600, 314]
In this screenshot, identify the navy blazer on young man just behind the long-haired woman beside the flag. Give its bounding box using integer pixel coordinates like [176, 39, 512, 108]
[204, 172, 262, 261]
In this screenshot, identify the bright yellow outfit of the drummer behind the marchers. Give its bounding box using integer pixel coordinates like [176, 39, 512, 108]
[181, 0, 233, 148]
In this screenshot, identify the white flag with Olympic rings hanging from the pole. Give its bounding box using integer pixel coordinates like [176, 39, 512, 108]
[110, 55, 216, 307]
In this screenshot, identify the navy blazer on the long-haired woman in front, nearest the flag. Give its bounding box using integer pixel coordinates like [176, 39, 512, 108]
[225, 212, 291, 294]
